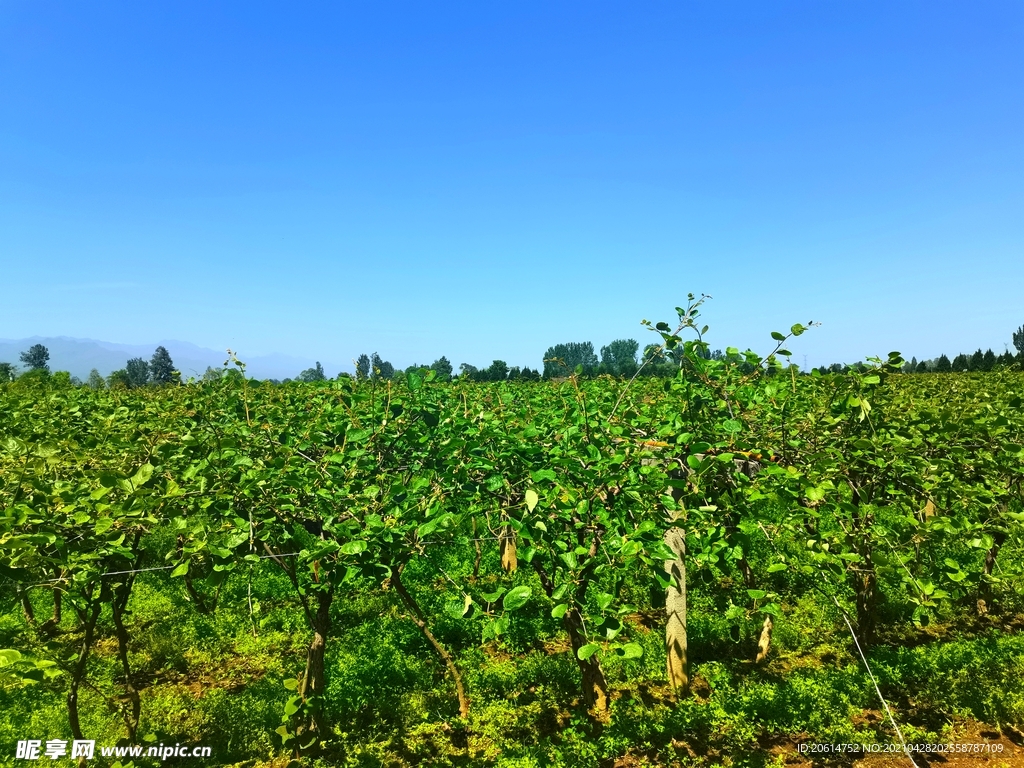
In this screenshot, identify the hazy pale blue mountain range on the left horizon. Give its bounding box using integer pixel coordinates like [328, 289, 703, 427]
[0, 336, 352, 381]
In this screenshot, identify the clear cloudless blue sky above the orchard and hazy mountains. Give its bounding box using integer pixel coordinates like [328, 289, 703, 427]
[0, 0, 1024, 374]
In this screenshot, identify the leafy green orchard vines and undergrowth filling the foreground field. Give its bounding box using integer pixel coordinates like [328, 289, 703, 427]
[0, 302, 1024, 767]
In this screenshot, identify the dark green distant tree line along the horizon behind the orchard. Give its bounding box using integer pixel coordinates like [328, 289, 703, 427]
[0, 326, 1024, 389]
